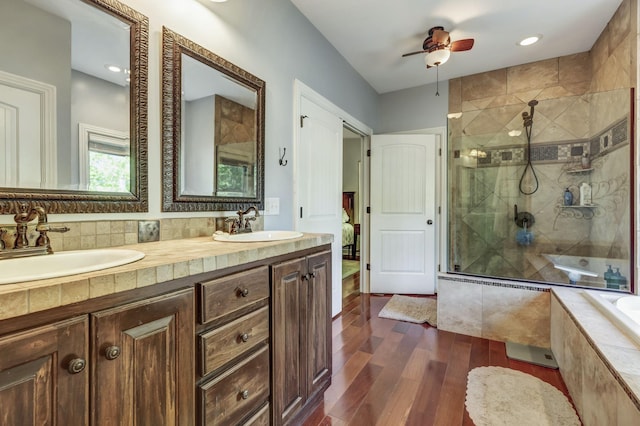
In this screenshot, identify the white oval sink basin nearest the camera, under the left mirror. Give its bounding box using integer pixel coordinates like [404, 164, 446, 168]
[0, 249, 144, 284]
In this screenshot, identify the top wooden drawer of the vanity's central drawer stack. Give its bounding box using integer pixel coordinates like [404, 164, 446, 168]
[200, 266, 269, 324]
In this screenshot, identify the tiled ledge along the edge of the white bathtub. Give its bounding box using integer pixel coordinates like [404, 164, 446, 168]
[552, 288, 640, 405]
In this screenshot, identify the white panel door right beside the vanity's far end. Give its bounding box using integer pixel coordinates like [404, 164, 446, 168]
[296, 96, 342, 315]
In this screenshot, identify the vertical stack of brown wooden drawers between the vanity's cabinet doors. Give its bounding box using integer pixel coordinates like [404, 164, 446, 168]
[197, 265, 271, 425]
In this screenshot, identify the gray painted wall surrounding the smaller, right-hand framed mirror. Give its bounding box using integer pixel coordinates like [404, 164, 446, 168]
[124, 0, 378, 229]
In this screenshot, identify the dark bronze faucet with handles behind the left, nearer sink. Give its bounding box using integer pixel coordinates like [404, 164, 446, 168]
[0, 204, 69, 259]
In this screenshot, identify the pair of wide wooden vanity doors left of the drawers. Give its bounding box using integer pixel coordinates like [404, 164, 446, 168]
[0, 288, 195, 426]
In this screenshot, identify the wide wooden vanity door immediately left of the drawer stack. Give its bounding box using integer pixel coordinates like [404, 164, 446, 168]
[91, 289, 195, 425]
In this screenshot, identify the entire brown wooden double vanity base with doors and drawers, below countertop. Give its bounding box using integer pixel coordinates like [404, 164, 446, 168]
[0, 241, 331, 426]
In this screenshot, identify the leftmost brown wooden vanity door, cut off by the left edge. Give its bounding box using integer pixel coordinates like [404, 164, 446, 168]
[0, 316, 89, 426]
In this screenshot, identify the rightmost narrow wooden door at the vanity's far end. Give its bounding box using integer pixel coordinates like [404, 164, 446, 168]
[305, 251, 331, 398]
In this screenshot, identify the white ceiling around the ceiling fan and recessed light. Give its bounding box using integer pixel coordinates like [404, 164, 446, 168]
[291, 0, 621, 93]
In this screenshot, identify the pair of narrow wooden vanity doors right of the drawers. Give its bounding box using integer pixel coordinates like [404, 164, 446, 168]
[271, 251, 331, 425]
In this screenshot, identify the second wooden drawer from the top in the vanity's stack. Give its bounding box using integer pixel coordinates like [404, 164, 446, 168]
[200, 306, 269, 376]
